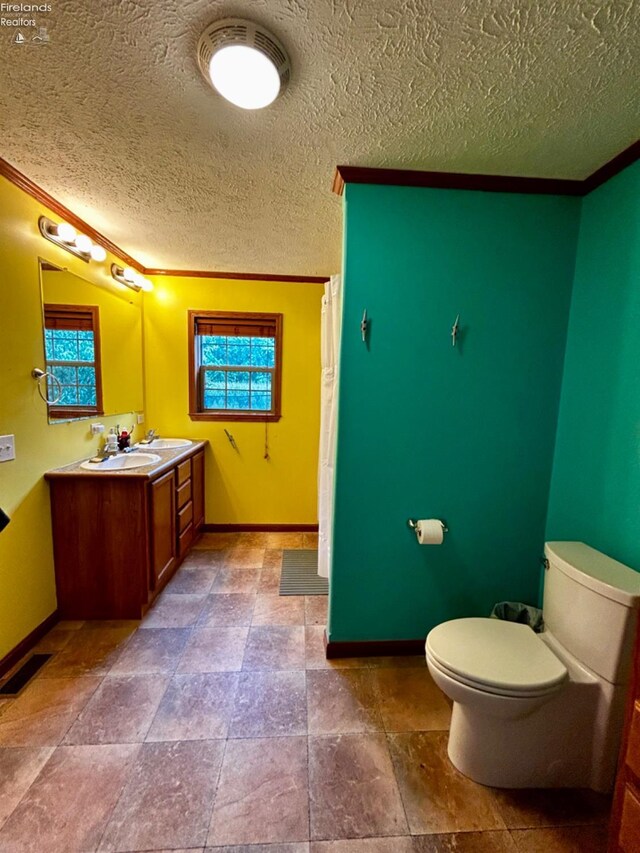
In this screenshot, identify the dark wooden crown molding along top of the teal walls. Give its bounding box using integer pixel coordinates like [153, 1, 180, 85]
[332, 141, 640, 196]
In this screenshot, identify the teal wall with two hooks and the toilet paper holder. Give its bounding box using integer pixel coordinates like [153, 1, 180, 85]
[328, 184, 580, 641]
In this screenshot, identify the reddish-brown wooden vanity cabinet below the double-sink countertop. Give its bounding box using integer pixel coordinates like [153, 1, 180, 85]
[45, 448, 204, 619]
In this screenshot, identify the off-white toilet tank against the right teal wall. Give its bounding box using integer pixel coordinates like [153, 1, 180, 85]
[542, 542, 640, 684]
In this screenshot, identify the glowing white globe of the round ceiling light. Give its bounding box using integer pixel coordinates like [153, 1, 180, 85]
[209, 44, 280, 110]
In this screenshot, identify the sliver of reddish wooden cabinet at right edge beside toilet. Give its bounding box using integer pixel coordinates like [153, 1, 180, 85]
[609, 626, 640, 853]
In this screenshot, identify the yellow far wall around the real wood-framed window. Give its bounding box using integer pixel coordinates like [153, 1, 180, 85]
[144, 276, 323, 524]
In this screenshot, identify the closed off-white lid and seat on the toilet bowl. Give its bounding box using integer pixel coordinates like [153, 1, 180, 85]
[426, 618, 567, 694]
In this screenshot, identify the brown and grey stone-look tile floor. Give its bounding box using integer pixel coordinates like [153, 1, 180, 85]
[0, 534, 609, 853]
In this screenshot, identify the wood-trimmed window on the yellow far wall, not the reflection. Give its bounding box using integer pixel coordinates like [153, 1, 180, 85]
[189, 311, 282, 421]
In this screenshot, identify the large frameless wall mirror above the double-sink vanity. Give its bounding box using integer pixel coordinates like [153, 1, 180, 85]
[40, 260, 143, 423]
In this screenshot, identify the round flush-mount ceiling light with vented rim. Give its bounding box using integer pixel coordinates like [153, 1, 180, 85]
[198, 18, 290, 110]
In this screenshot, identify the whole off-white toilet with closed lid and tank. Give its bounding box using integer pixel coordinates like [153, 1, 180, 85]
[426, 542, 640, 792]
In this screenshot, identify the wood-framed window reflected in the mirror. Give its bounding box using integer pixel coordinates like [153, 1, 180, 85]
[44, 304, 104, 418]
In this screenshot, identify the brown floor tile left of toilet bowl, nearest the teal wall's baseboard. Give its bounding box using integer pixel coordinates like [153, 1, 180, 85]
[371, 667, 451, 732]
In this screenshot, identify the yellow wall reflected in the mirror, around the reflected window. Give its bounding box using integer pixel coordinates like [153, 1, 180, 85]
[42, 270, 143, 414]
